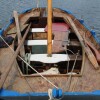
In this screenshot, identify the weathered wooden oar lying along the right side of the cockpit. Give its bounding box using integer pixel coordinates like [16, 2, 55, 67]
[64, 16, 99, 69]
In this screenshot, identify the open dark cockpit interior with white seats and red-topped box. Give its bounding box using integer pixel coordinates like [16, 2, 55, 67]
[14, 9, 84, 76]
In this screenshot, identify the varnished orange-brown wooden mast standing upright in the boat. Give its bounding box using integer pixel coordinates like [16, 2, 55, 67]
[47, 0, 52, 57]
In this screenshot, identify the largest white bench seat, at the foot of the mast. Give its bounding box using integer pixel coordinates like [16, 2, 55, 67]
[30, 54, 70, 63]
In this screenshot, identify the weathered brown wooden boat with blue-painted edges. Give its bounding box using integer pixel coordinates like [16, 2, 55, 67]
[0, 0, 100, 100]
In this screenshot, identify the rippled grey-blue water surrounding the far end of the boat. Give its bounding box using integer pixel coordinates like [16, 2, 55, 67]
[0, 0, 100, 39]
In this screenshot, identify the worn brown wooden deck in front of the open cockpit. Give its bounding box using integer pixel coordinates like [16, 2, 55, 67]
[0, 39, 100, 93]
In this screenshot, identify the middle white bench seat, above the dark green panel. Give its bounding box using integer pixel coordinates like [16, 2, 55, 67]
[25, 40, 53, 46]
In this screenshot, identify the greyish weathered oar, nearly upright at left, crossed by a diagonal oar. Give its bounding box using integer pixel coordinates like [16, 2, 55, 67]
[13, 11, 25, 57]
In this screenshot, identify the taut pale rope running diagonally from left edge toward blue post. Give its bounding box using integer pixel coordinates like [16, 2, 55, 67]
[0, 35, 59, 89]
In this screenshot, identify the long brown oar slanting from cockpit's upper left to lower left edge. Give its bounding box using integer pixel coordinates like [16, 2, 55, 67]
[0, 24, 31, 88]
